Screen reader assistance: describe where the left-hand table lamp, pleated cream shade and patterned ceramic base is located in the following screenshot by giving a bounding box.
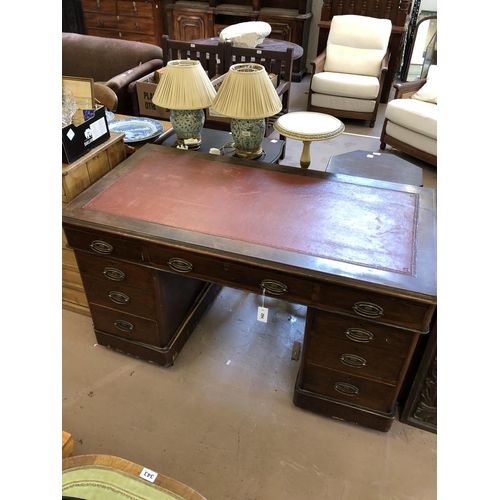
[153,59,215,148]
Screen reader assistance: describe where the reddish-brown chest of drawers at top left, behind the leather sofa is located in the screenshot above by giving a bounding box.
[81,0,163,47]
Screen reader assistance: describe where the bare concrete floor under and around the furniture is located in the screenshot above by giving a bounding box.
[62,78,437,500]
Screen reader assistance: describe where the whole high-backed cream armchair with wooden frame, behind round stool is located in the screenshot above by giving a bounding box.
[307,14,392,127]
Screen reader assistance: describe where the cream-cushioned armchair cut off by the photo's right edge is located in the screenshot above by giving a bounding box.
[380,65,437,166]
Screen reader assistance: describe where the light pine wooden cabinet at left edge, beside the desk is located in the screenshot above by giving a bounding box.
[62,132,126,316]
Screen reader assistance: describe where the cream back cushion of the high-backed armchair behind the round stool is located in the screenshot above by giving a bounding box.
[324,15,392,76]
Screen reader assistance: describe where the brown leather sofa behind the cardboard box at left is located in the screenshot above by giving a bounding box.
[62,33,163,115]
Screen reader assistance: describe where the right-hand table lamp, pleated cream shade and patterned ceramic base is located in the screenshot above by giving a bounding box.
[212,63,282,159]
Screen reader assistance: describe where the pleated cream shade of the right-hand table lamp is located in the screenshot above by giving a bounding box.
[210,63,282,120]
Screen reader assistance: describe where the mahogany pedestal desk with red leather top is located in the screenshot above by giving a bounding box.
[63,144,437,431]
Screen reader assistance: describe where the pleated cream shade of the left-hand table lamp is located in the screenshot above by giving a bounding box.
[153,59,215,110]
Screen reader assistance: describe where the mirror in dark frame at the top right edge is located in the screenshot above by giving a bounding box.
[401,16,437,82]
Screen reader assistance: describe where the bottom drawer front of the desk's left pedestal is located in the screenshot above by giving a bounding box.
[89,303,164,347]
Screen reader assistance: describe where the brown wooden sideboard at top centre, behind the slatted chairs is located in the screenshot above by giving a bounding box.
[164,0,312,81]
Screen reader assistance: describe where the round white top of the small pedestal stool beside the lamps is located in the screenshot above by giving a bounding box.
[274,111,345,141]
